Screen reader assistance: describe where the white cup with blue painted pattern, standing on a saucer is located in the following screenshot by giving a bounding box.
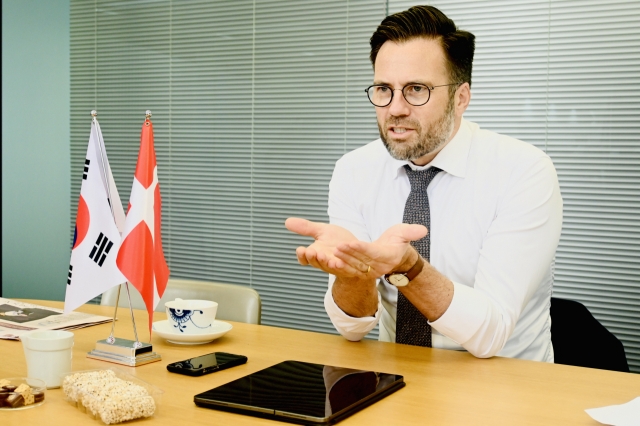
[164,298,218,334]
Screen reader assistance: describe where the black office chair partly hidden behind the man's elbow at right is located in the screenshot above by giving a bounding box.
[551,297,629,373]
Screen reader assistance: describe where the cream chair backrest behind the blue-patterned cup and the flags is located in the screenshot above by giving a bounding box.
[100,279,262,324]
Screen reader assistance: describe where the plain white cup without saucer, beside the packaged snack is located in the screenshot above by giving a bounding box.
[20,330,73,389]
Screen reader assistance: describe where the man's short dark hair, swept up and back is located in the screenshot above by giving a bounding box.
[369,6,476,85]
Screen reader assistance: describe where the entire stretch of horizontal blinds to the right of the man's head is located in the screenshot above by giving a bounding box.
[389,0,640,372]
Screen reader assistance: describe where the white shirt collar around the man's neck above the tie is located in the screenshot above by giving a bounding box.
[391,118,473,178]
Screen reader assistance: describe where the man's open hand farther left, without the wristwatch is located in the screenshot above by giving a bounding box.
[284,217,369,277]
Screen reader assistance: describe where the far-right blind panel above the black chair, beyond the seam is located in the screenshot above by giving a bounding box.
[548,0,640,372]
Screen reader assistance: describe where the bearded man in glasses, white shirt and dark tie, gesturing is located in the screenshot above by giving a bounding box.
[286,6,562,362]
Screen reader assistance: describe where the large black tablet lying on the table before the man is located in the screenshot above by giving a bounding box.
[194,361,405,425]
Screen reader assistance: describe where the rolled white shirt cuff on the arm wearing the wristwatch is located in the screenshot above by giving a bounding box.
[429,282,498,353]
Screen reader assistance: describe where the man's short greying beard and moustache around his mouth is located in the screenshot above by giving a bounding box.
[378,97,455,161]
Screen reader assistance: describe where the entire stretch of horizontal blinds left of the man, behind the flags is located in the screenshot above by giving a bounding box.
[71,0,385,338]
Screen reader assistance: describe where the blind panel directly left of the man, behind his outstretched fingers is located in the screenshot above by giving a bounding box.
[251,0,384,332]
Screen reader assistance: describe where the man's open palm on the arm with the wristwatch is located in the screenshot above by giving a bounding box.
[334,223,427,277]
